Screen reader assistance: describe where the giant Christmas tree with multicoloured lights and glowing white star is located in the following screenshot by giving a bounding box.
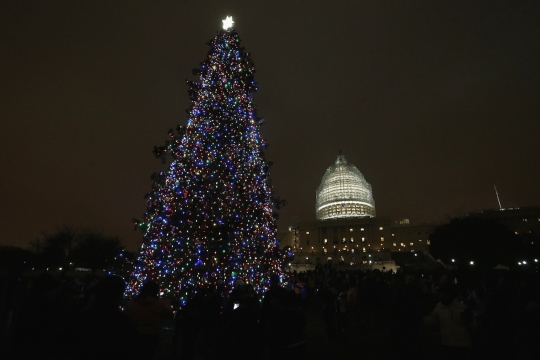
[128,18,282,306]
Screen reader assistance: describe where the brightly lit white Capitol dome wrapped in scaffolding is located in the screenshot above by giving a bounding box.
[316,152,375,220]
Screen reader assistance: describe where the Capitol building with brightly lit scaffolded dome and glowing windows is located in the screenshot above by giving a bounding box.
[279,152,434,269]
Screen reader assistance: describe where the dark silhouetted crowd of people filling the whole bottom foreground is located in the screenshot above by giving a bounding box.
[0,264,540,360]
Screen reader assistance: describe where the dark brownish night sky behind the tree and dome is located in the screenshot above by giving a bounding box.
[0,0,540,249]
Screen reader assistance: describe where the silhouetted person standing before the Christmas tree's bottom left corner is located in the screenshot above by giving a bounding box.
[126,281,172,359]
